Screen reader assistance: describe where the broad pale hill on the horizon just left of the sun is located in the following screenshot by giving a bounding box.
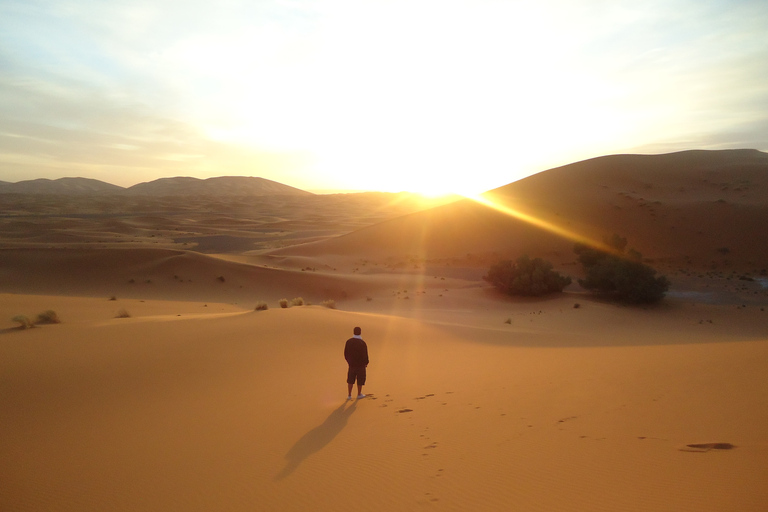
[125,176,314,196]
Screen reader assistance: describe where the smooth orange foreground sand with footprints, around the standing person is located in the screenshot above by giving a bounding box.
[0,294,768,511]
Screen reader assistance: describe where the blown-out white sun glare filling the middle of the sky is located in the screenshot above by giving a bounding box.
[192,2,656,198]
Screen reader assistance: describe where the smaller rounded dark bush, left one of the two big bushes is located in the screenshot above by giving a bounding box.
[483,256,571,296]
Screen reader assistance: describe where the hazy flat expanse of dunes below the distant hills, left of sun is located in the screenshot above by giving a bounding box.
[0,191,456,253]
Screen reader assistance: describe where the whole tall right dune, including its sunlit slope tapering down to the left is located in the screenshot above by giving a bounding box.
[274,150,768,267]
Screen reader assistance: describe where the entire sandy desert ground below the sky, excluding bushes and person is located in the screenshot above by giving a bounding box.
[0,150,768,512]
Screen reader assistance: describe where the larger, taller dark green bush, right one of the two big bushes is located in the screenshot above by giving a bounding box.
[574,235,670,304]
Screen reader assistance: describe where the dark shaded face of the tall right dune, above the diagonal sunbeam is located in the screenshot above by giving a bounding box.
[487,150,768,267]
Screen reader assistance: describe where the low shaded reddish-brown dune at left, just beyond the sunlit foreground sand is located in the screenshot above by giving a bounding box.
[0,249,387,302]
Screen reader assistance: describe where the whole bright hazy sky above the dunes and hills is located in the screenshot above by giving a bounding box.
[0,0,768,193]
